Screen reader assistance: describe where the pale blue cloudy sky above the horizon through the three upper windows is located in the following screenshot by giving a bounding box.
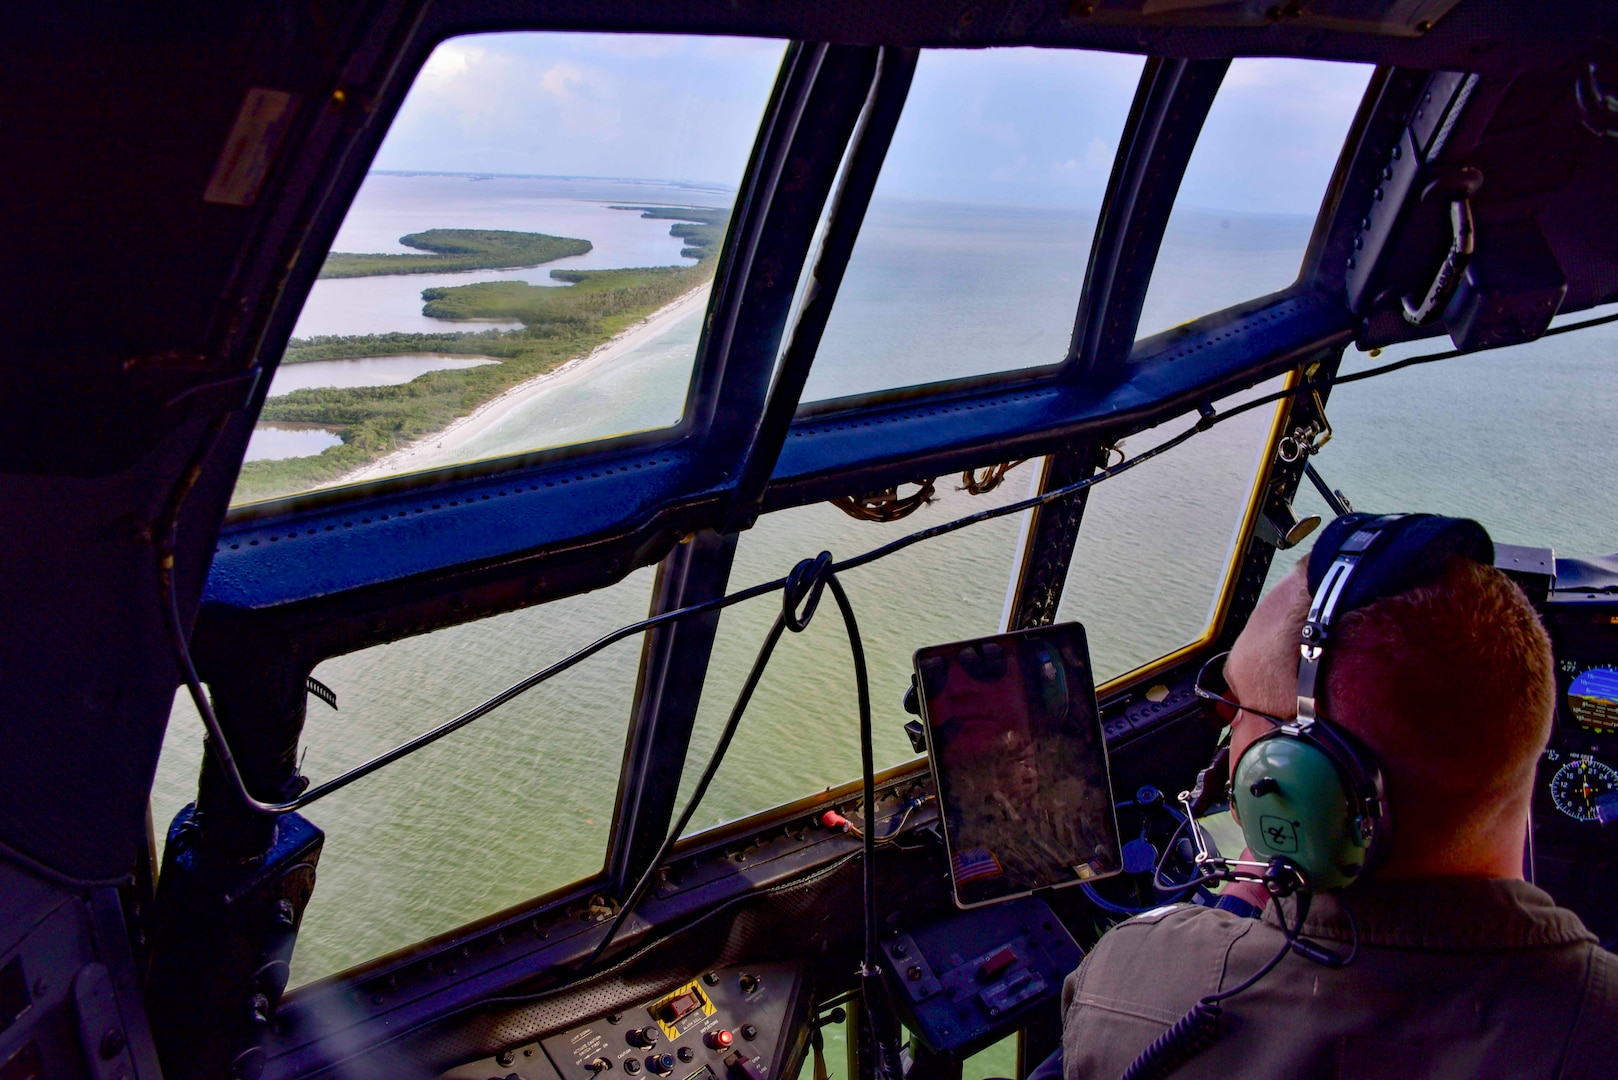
[375,32,1370,214]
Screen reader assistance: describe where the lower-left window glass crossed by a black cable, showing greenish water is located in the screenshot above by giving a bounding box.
[152,568,654,983]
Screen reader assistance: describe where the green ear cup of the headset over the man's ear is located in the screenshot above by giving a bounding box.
[1231,730,1369,889]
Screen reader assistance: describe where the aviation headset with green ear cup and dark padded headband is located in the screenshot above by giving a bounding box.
[1230,513,1495,891]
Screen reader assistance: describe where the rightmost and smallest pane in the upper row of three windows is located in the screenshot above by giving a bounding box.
[1139,58,1372,337]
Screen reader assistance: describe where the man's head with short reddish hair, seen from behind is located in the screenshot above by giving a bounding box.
[1225,555,1555,876]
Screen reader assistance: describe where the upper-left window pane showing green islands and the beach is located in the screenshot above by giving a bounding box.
[235,32,783,502]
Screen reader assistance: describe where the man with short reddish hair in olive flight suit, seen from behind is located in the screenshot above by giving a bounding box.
[1063,527,1618,1080]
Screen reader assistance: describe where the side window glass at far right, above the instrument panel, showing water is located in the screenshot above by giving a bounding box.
[1270,308,1618,583]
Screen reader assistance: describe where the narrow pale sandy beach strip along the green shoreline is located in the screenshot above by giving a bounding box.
[337,283,710,484]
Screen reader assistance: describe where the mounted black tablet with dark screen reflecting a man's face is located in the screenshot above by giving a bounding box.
[916,622,1120,908]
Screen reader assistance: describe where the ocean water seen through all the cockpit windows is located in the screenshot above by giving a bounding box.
[154,176,1618,983]
